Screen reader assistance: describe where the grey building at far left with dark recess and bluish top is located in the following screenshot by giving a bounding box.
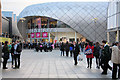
[2,11,21,41]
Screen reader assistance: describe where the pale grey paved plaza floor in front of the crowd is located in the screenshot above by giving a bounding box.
[2,50,111,78]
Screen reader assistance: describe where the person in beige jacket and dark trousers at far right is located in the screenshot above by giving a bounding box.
[111,42,120,79]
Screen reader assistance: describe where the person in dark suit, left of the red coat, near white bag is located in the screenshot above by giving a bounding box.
[73,42,80,65]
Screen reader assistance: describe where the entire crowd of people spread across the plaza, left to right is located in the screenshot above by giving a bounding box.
[2,40,120,79]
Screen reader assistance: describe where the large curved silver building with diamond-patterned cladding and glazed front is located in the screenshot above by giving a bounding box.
[18,2,108,42]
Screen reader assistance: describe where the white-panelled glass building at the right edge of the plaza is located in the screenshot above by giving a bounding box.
[107,0,120,43]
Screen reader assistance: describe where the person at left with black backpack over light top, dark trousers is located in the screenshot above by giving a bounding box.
[14,41,22,69]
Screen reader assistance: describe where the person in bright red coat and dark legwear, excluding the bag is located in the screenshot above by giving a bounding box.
[85,42,94,69]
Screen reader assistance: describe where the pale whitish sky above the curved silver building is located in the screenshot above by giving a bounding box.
[1,0,109,16]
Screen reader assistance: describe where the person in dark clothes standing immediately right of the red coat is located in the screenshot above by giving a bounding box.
[93,42,100,69]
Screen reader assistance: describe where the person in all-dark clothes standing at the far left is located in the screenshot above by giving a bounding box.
[2,41,9,69]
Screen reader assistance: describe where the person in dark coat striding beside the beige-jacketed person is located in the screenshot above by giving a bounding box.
[101,40,112,75]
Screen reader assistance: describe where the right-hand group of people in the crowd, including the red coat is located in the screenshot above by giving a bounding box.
[60,40,120,79]
